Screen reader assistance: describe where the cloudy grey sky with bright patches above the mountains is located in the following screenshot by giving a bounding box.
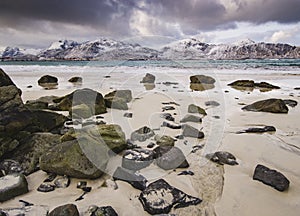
[0,0,300,48]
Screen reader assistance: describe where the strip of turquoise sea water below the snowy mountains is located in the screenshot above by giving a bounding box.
[0,59,300,69]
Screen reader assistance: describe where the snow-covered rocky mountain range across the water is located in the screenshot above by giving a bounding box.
[0,38,300,60]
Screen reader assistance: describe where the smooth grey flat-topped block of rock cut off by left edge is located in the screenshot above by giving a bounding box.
[0,173,28,202]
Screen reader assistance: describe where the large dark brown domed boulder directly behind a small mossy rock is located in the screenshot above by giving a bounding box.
[53,88,106,115]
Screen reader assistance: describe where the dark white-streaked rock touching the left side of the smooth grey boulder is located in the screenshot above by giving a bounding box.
[122,148,153,171]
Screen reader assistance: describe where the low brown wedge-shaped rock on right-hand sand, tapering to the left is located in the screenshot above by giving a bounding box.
[242,98,289,113]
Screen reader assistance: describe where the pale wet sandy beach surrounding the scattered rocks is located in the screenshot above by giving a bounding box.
[0,66,300,216]
